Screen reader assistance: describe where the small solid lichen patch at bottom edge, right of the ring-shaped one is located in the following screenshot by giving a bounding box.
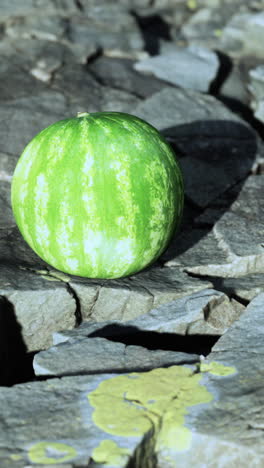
[92,440,130,466]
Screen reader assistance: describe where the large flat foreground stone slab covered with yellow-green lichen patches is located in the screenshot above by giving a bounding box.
[0,294,264,468]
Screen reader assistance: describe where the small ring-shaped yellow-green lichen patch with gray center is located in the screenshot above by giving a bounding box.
[28,441,77,465]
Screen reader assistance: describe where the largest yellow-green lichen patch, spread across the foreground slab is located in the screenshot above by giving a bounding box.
[88,366,213,450]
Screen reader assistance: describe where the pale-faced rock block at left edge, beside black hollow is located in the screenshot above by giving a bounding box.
[0,264,76,351]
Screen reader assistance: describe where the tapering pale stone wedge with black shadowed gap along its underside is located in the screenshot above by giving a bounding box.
[51,289,241,360]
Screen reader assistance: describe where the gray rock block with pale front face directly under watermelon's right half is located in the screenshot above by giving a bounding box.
[68,265,211,322]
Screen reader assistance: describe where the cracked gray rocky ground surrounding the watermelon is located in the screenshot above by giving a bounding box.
[0,0,264,468]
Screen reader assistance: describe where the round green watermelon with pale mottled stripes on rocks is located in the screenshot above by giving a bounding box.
[11,112,184,278]
